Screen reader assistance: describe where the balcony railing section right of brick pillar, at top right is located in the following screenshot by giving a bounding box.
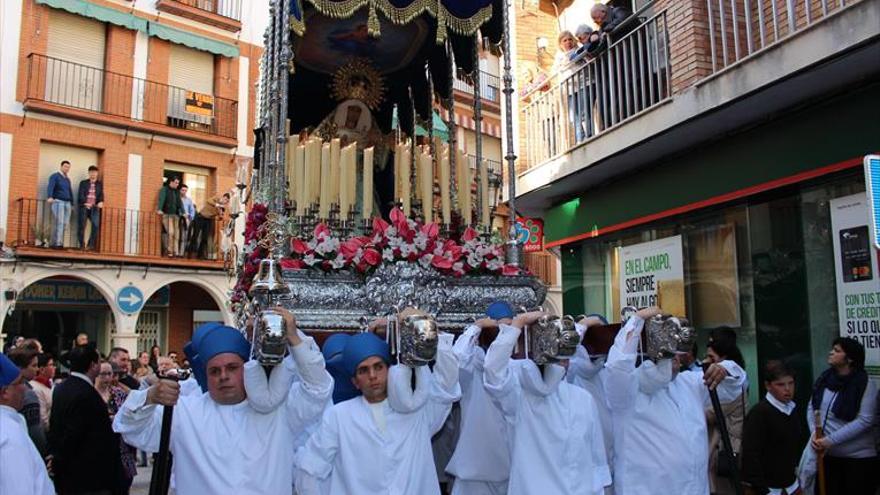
[706,0,862,73]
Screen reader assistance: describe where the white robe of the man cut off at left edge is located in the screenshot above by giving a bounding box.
[0,405,55,495]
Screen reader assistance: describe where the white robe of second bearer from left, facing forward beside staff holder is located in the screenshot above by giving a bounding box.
[295,338,461,495]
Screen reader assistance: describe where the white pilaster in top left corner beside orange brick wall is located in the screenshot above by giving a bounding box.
[0,0,23,116]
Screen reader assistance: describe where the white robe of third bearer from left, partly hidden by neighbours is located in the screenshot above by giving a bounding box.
[446,325,510,495]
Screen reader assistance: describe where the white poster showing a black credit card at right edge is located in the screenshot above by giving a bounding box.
[831,193,880,377]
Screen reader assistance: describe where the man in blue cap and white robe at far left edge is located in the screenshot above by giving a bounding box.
[0,354,55,495]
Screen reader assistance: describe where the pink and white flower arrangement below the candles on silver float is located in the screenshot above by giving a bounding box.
[282,208,522,277]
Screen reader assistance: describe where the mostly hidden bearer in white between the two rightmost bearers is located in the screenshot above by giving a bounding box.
[565,315,614,468]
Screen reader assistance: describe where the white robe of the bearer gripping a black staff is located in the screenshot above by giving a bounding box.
[113,342,333,495]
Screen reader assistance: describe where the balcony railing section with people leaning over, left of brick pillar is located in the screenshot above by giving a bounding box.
[522,10,672,167]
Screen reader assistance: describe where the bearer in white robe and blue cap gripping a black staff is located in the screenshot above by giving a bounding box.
[113,309,333,495]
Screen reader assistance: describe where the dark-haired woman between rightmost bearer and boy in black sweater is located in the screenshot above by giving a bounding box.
[706,328,748,495]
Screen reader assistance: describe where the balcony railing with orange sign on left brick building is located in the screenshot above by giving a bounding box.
[27,53,238,139]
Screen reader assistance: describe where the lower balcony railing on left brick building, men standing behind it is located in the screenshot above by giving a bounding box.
[8,198,231,269]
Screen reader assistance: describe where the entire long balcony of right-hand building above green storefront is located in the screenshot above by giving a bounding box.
[517,0,877,198]
